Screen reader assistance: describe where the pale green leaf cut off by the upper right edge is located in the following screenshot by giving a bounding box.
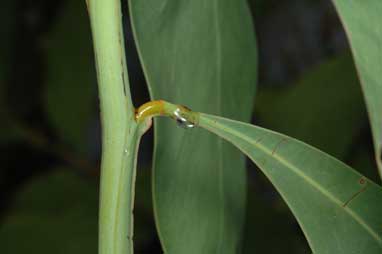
[333,0,382,177]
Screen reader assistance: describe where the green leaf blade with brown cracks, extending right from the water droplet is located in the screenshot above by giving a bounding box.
[199,114,382,254]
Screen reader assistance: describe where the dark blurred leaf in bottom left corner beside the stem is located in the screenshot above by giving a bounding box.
[0,169,98,254]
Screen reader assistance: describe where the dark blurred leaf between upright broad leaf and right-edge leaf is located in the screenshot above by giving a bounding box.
[255,54,366,158]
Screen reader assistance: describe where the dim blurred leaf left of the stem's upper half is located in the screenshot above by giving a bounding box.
[44,0,96,151]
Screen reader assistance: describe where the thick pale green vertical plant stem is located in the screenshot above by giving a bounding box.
[87,0,145,254]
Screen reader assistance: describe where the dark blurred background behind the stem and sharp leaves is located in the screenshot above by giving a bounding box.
[0,0,379,254]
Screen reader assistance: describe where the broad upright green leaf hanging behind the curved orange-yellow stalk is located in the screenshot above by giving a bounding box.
[130,0,257,254]
